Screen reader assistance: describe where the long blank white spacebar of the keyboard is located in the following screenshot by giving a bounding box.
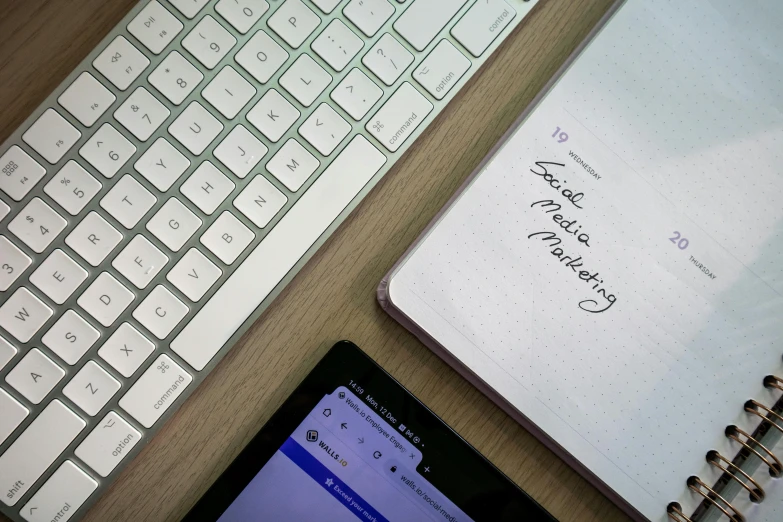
[171,136,386,371]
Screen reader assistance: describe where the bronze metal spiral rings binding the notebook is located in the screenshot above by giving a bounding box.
[666,375,783,522]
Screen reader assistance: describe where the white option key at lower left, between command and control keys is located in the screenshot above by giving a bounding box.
[74,411,141,477]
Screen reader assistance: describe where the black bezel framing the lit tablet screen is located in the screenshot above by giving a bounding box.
[184,341,556,522]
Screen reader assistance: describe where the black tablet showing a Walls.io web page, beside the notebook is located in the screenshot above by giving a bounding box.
[185,341,555,522]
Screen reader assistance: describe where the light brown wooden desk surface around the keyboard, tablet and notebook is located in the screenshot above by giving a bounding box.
[0,0,627,522]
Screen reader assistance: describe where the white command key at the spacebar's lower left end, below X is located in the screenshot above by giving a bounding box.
[119,355,193,424]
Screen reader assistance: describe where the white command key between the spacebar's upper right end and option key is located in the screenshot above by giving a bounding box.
[364,82,432,152]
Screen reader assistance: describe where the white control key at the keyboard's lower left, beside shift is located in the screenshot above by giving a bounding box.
[20,460,98,522]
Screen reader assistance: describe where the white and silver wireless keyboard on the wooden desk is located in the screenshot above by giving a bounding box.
[0,0,536,522]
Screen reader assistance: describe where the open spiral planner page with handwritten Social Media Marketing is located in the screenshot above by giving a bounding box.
[379,0,783,522]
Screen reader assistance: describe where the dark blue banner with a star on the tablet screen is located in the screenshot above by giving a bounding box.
[280,437,389,522]
